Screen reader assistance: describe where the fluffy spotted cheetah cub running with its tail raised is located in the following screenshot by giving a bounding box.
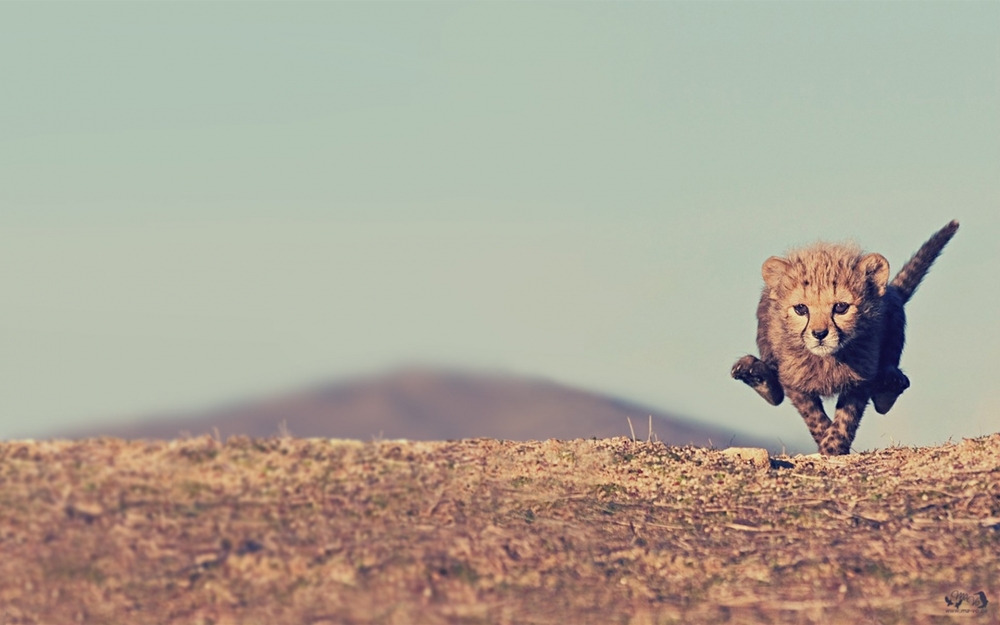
[731,221,958,456]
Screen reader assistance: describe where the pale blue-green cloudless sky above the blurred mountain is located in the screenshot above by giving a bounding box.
[0,2,1000,449]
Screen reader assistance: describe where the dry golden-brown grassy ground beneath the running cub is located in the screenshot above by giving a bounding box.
[0,435,1000,625]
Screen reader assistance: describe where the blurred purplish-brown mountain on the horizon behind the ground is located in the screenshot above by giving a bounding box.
[64,369,773,447]
